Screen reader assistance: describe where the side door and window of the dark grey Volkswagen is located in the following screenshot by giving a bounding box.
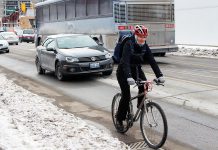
[46,39,57,71]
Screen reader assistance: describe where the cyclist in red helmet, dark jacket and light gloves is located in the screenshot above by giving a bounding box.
[116,25,165,130]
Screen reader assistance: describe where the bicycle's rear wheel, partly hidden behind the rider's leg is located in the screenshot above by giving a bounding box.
[111,93,129,133]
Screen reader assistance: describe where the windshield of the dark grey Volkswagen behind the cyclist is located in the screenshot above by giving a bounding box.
[57,35,98,49]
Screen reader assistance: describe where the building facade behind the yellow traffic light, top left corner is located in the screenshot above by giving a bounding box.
[0,0,42,31]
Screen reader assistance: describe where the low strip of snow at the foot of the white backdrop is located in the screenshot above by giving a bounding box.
[170,45,218,58]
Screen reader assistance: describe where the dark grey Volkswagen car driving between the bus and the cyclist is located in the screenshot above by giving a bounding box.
[35,34,113,80]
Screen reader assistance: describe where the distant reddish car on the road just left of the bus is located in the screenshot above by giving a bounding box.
[20,29,35,43]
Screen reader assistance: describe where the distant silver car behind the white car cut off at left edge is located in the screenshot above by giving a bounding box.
[0,32,19,45]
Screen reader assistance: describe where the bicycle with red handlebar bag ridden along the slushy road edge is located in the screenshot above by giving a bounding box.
[111,79,168,149]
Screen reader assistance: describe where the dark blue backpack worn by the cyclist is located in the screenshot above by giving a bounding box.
[112,31,133,63]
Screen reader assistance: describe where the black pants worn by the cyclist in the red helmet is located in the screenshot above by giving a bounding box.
[117,66,146,121]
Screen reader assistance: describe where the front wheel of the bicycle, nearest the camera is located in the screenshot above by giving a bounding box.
[140,102,168,149]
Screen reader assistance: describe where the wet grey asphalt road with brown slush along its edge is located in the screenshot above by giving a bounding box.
[0,43,218,149]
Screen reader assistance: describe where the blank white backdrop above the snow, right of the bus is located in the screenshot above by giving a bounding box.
[175,0,218,46]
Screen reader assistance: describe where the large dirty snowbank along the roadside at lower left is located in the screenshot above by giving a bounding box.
[0,74,130,150]
